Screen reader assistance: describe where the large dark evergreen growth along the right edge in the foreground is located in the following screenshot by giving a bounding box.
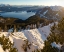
[42,18,64,52]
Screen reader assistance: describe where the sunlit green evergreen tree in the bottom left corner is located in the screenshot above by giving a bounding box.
[0,35,17,52]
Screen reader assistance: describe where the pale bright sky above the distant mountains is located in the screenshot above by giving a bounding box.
[0,0,64,6]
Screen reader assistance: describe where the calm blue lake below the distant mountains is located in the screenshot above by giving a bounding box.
[0,11,35,20]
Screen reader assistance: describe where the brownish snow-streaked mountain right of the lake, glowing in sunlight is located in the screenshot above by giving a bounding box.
[36,6,64,20]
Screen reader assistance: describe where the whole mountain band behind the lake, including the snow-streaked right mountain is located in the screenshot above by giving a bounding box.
[0,4,64,20]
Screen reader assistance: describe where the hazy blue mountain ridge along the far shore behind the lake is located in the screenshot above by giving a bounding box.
[0,4,44,12]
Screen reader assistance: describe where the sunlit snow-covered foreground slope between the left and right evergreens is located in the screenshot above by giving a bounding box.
[0,24,51,52]
